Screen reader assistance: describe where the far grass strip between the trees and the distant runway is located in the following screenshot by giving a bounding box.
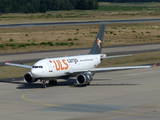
[0,3,160,24]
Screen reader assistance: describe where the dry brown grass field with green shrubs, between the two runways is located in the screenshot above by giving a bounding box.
[0,22,160,54]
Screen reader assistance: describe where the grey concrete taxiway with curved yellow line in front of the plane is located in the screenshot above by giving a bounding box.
[0,67,160,120]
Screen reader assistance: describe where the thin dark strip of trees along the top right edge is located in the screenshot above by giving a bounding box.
[97,0,160,3]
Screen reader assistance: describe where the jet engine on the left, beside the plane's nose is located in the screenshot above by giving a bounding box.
[23,72,38,83]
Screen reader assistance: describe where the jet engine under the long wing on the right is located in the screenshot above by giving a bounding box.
[76,73,93,85]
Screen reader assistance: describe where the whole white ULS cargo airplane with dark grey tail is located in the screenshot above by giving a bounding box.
[5,24,151,88]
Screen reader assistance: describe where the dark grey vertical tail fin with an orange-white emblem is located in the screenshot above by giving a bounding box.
[89,24,105,54]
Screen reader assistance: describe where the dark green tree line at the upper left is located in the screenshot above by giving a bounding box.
[0,0,98,13]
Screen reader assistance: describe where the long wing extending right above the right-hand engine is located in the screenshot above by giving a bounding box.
[69,66,152,74]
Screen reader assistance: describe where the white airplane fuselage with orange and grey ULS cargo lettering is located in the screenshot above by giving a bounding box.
[31,54,101,79]
